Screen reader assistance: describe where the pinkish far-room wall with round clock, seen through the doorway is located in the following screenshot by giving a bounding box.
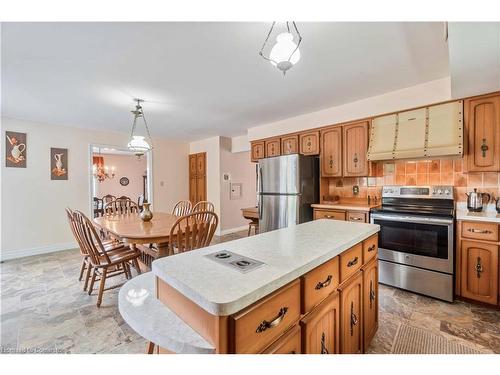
[94,154,147,202]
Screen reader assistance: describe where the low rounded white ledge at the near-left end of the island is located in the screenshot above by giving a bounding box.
[118,272,215,354]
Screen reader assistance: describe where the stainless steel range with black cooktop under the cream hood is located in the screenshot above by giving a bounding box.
[371,186,455,301]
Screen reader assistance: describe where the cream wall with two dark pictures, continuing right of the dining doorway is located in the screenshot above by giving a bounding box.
[1,118,189,259]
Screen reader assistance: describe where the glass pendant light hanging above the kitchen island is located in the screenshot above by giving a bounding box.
[259,21,302,75]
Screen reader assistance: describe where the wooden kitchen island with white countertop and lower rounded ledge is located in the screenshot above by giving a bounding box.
[119,220,379,353]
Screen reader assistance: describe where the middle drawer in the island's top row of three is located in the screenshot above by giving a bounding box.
[301,257,340,314]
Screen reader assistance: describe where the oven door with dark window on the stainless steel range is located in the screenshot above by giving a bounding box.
[371,213,453,274]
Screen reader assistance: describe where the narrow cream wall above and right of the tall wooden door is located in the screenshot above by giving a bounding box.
[189,137,221,235]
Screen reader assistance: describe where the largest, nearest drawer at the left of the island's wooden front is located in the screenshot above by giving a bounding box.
[229,280,300,353]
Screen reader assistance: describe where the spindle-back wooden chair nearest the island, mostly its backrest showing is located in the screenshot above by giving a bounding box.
[168,211,219,255]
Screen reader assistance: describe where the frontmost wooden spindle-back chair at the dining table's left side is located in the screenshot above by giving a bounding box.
[73,211,141,307]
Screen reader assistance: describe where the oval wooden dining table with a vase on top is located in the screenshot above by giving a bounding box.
[94,212,181,266]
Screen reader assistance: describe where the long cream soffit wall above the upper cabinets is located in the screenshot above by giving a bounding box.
[248,77,451,141]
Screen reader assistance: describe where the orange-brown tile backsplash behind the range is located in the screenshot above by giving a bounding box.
[328,159,500,202]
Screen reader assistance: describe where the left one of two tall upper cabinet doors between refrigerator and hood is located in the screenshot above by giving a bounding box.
[320,126,342,177]
